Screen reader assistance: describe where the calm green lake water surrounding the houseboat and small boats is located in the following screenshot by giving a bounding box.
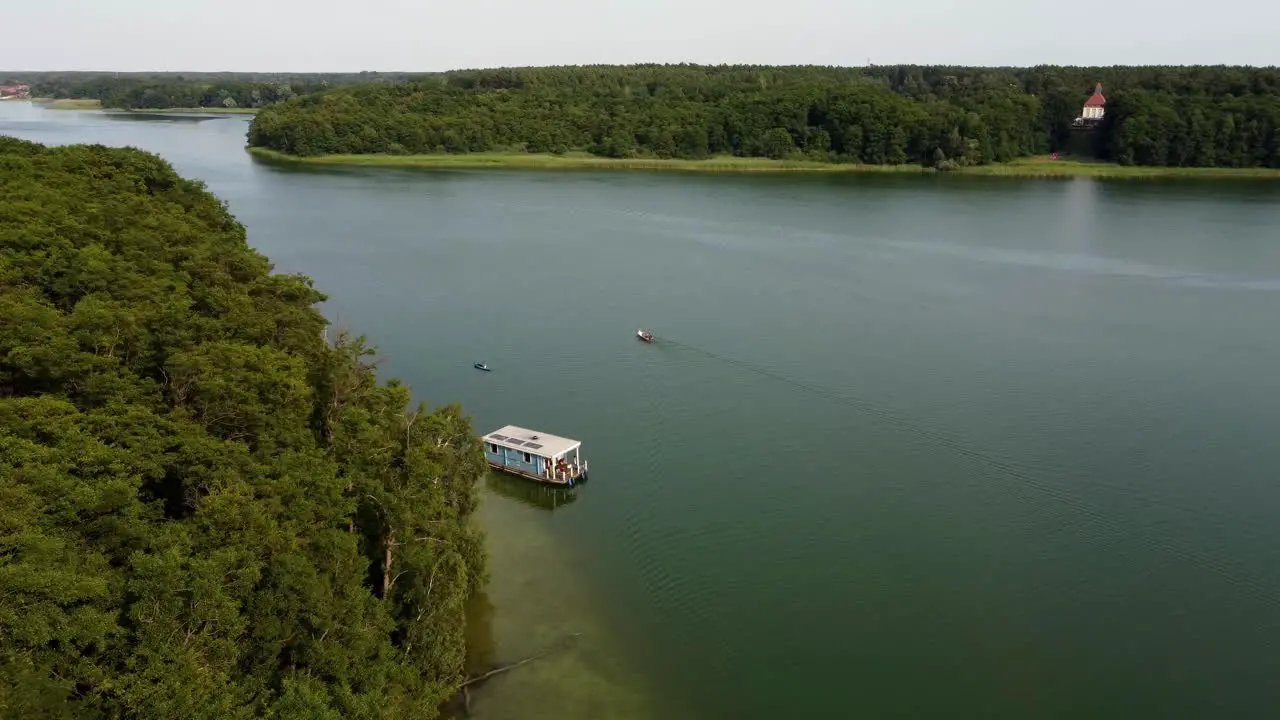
[0,102,1280,720]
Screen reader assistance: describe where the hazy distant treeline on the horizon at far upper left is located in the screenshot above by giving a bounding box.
[18,72,416,110]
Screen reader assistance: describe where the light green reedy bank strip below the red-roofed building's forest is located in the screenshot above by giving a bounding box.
[248,146,1280,179]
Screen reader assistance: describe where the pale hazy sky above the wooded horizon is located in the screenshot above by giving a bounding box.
[0,0,1280,72]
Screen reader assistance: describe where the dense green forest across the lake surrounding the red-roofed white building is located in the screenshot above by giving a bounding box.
[241,65,1280,169]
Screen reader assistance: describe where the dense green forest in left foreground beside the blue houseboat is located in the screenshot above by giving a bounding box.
[0,137,485,720]
